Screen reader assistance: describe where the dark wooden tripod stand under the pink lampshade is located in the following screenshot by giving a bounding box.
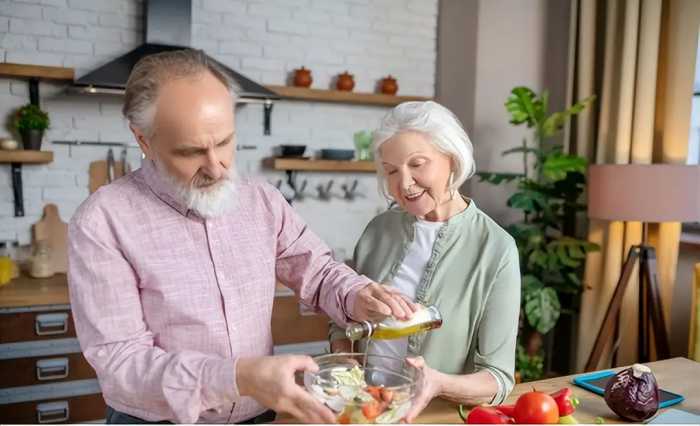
[586,241,670,371]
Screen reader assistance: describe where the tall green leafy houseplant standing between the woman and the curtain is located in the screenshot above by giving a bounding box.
[478,87,598,379]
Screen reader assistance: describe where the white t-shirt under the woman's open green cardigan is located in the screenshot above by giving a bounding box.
[369,219,444,358]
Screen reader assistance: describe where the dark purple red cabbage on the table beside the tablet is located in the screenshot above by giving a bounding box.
[605,364,659,423]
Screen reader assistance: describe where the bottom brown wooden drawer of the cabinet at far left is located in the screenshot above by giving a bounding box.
[0,394,107,424]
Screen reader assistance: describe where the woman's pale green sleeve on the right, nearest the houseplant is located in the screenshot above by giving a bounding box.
[474,240,520,404]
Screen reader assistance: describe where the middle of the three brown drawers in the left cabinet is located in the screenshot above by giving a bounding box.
[0,353,96,388]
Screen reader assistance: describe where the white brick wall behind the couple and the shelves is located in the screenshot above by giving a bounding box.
[0,0,437,256]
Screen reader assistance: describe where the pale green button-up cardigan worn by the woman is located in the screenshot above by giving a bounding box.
[330,200,520,404]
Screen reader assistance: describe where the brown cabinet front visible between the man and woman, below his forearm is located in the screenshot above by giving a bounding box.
[272,296,329,345]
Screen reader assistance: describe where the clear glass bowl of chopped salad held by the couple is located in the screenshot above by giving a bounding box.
[304,353,421,424]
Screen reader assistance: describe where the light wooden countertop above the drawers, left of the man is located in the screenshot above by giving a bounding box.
[0,274,70,308]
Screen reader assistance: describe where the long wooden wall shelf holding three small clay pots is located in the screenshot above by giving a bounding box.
[267,86,431,106]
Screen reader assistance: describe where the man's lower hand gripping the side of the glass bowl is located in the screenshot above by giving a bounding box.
[236,355,336,424]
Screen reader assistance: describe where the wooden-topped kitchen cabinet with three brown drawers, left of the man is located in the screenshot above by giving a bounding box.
[0,274,106,423]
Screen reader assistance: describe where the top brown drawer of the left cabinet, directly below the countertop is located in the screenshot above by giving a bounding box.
[0,310,75,343]
